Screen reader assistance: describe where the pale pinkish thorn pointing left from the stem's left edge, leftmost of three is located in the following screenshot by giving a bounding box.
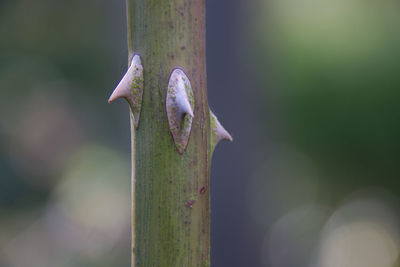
[108,55,143,128]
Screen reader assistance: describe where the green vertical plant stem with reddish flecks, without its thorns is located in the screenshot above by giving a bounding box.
[127,0,211,267]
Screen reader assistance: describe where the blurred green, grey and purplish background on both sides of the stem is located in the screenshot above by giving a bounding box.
[0,0,400,267]
